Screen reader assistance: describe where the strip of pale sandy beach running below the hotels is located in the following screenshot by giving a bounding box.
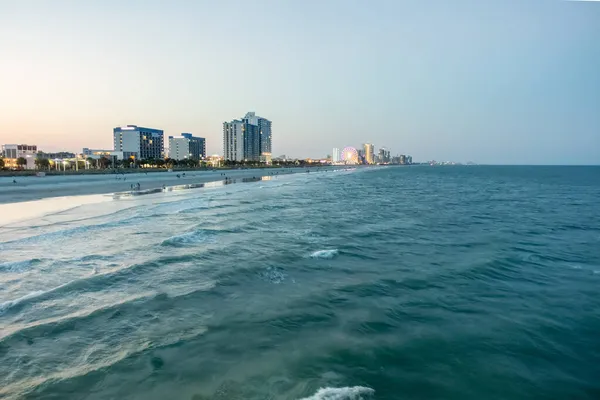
[0,168,325,204]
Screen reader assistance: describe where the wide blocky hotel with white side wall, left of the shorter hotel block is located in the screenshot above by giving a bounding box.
[113,125,165,160]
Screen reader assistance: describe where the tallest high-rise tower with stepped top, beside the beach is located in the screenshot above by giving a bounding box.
[223,112,272,163]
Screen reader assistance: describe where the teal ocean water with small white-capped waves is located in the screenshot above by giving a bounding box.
[0,166,600,400]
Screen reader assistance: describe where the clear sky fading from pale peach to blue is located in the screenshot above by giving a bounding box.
[0,0,600,164]
